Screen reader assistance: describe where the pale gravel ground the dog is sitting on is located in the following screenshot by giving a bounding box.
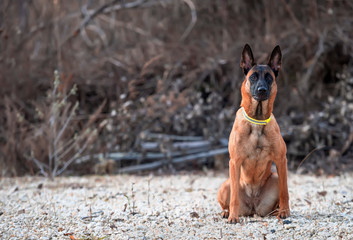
[0,172,353,239]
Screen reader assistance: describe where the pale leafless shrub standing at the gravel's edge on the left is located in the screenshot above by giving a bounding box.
[26,71,97,178]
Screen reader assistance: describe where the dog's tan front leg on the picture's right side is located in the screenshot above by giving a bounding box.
[275,156,290,218]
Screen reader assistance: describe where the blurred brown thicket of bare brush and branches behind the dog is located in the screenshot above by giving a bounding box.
[0,0,353,176]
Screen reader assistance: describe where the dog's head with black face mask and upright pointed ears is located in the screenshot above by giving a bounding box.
[240,44,282,102]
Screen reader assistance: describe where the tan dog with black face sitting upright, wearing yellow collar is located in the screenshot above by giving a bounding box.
[217,44,290,223]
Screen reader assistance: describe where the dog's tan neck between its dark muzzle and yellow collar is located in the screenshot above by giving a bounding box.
[240,84,276,120]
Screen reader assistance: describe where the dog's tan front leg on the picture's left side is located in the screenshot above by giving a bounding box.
[228,159,240,223]
